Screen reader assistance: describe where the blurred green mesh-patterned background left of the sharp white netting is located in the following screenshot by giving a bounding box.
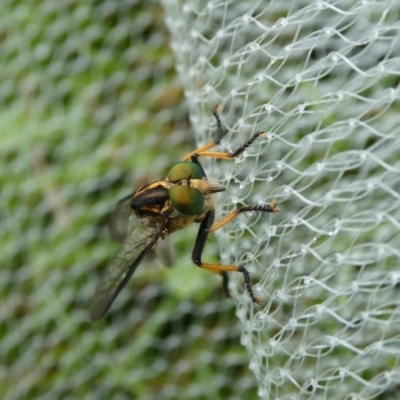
[0,0,256,400]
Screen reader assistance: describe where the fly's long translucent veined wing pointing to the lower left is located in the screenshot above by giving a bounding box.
[89,214,159,321]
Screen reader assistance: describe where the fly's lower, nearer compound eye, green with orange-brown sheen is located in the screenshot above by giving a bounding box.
[169,185,204,215]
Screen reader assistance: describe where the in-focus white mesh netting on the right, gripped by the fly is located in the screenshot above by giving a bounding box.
[164,0,400,399]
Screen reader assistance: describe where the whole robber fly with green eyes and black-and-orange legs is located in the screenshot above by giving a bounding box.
[90,109,279,320]
